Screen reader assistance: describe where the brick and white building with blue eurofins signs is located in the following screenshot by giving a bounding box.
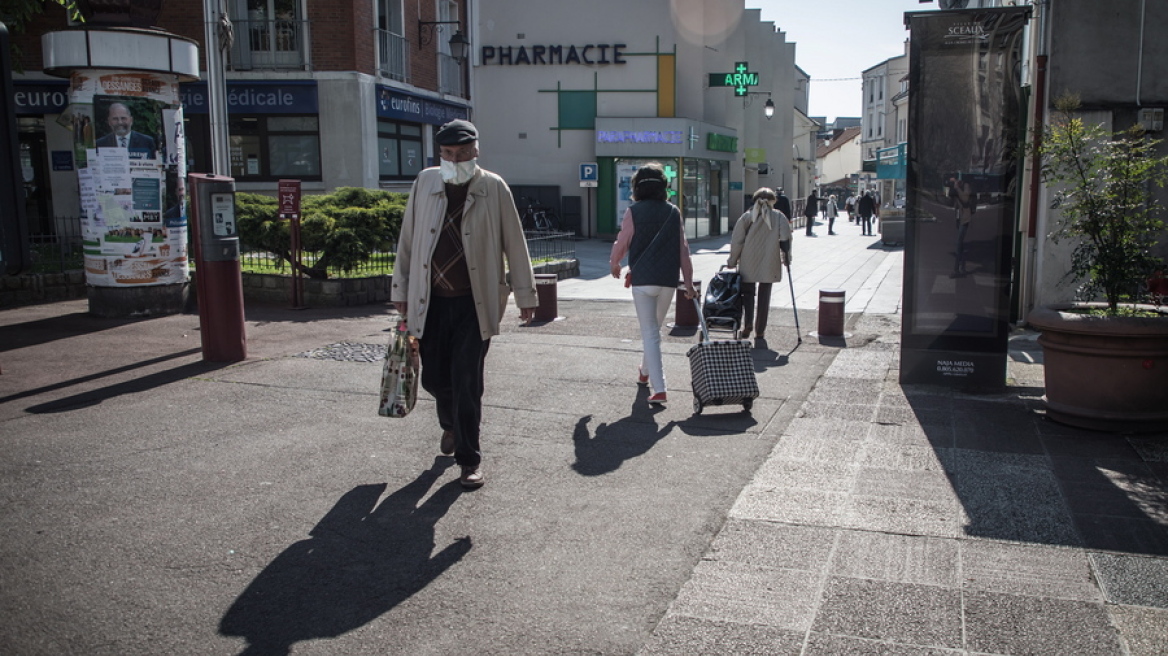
[14,0,471,233]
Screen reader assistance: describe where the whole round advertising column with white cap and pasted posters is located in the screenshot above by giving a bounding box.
[43,29,197,316]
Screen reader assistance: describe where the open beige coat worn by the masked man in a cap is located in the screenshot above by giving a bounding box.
[390,167,540,340]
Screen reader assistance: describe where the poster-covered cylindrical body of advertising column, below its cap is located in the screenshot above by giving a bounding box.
[70,70,188,287]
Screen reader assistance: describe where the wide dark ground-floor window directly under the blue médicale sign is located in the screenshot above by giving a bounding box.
[219,114,320,180]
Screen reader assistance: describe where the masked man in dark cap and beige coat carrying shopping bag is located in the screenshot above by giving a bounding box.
[390,120,540,488]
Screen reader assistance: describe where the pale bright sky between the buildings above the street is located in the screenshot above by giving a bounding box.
[746,0,937,120]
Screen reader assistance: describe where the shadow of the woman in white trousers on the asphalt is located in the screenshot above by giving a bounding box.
[572,388,677,476]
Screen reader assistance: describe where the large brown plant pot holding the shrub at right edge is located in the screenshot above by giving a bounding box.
[1028,303,1168,432]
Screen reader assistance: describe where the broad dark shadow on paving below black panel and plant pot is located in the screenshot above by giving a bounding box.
[903,386,1168,556]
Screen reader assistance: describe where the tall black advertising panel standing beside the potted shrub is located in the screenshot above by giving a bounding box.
[901,7,1029,388]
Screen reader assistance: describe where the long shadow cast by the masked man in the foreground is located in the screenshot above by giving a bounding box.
[220,458,471,656]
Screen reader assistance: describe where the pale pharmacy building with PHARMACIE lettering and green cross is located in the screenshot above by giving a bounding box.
[472,0,795,238]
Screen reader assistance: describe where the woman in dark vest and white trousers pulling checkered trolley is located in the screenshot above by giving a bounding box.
[609,162,697,405]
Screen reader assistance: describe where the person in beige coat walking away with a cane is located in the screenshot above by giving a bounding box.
[726,187,791,346]
